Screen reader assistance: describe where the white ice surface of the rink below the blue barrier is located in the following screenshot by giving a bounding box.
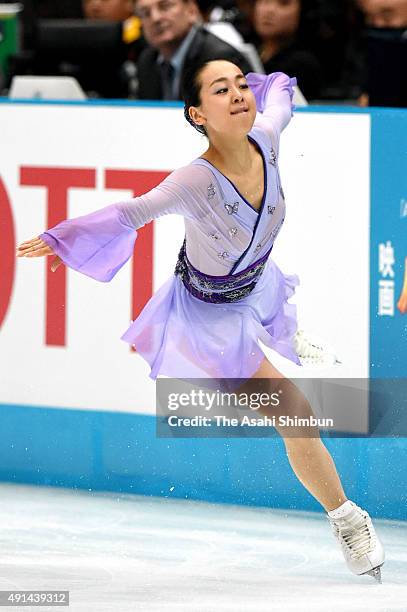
[0,483,407,612]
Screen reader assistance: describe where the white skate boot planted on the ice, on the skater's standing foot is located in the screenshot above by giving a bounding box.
[327,500,384,582]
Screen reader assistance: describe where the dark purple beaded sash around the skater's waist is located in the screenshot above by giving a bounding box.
[174,241,271,304]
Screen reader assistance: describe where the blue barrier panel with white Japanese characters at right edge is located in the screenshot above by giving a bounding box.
[369,110,407,378]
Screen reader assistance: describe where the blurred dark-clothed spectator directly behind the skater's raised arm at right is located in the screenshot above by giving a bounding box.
[253,0,322,99]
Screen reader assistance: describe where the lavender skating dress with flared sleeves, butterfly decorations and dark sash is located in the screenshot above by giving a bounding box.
[40,73,301,379]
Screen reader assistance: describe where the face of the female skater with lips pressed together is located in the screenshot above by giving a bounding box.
[189,60,256,140]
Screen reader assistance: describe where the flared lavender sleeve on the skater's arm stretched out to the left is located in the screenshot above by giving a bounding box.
[39,165,207,282]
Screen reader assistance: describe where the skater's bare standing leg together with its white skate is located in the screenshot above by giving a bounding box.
[237,359,384,582]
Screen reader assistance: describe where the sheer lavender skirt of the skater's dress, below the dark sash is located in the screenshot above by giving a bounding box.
[121,259,301,379]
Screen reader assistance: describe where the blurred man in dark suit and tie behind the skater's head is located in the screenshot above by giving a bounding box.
[136,0,251,100]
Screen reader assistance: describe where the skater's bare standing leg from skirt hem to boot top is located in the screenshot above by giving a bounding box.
[239,358,347,512]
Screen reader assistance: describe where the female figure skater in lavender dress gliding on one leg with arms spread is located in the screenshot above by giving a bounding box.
[17,60,384,581]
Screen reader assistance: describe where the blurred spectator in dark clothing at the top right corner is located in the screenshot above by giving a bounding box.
[358,0,407,107]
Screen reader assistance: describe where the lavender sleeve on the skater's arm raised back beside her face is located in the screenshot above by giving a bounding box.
[246,72,297,155]
